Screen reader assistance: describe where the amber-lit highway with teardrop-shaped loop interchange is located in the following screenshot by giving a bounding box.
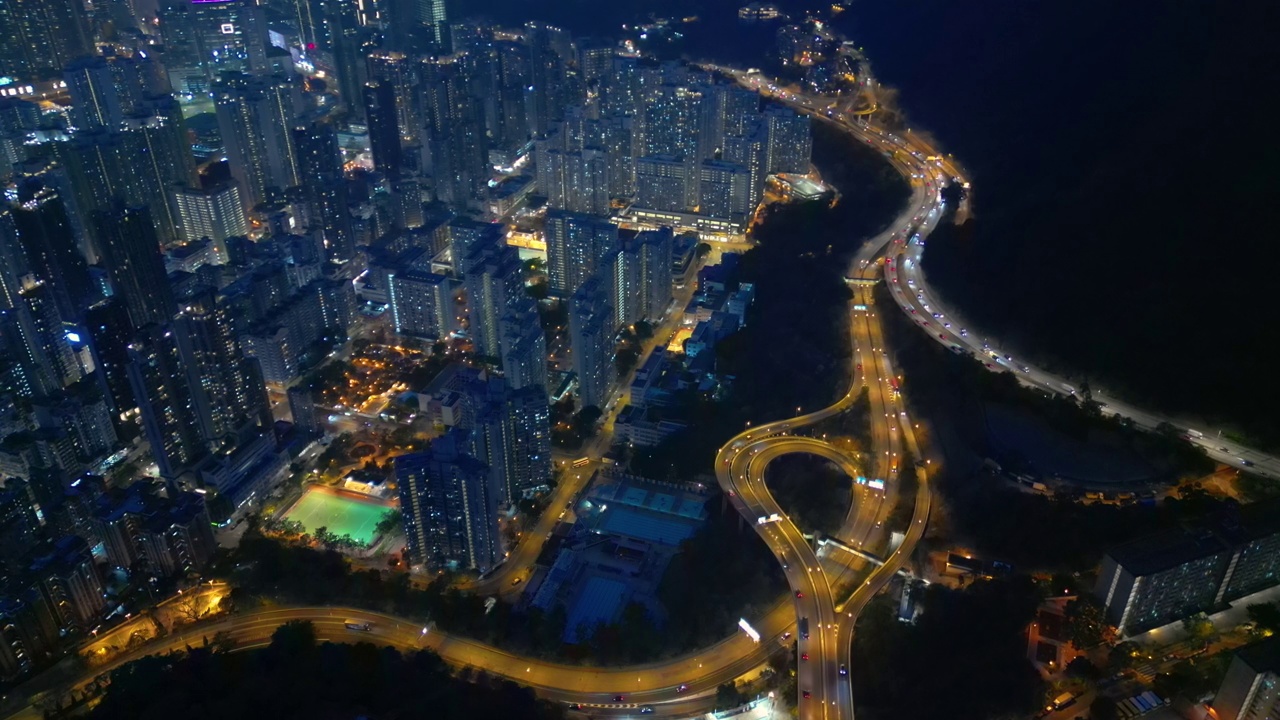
[7,61,952,720]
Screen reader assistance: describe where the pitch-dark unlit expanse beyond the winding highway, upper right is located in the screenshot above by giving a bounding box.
[468,0,1280,447]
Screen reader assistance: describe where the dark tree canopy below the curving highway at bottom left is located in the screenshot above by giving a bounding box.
[88,621,564,720]
